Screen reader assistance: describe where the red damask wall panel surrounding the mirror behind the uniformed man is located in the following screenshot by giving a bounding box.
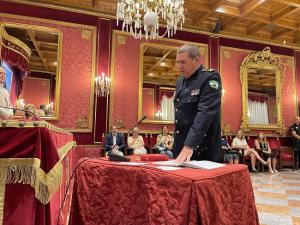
[110,33,208,132]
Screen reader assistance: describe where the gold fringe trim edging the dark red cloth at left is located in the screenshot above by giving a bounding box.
[0,141,76,205]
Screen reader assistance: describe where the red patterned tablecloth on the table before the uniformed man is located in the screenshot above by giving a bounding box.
[70,159,259,225]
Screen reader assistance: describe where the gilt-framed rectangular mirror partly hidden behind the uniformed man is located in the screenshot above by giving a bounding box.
[138,43,207,124]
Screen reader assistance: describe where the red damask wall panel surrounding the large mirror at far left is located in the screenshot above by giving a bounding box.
[0,16,96,131]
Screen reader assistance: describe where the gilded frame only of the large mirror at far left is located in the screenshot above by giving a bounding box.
[0,22,63,120]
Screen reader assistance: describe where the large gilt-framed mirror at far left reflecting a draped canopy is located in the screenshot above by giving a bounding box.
[1,23,62,119]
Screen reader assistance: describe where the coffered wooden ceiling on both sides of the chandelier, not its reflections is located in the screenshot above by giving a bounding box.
[9,0,300,48]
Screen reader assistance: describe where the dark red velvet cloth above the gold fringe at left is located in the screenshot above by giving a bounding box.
[0,127,73,173]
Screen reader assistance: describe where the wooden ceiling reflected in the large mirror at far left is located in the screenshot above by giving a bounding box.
[5,26,58,75]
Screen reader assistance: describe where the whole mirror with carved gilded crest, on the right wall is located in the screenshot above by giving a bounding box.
[241,48,284,133]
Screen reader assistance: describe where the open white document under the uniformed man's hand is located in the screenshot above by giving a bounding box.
[152,160,225,169]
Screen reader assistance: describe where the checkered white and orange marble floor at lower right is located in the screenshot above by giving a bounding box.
[251,170,300,225]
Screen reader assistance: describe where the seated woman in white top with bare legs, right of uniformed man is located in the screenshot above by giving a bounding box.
[231,130,268,172]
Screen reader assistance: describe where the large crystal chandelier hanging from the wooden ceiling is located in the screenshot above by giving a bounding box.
[116,0,185,40]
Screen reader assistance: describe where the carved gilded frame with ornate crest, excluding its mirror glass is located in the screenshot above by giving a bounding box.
[240,47,285,134]
